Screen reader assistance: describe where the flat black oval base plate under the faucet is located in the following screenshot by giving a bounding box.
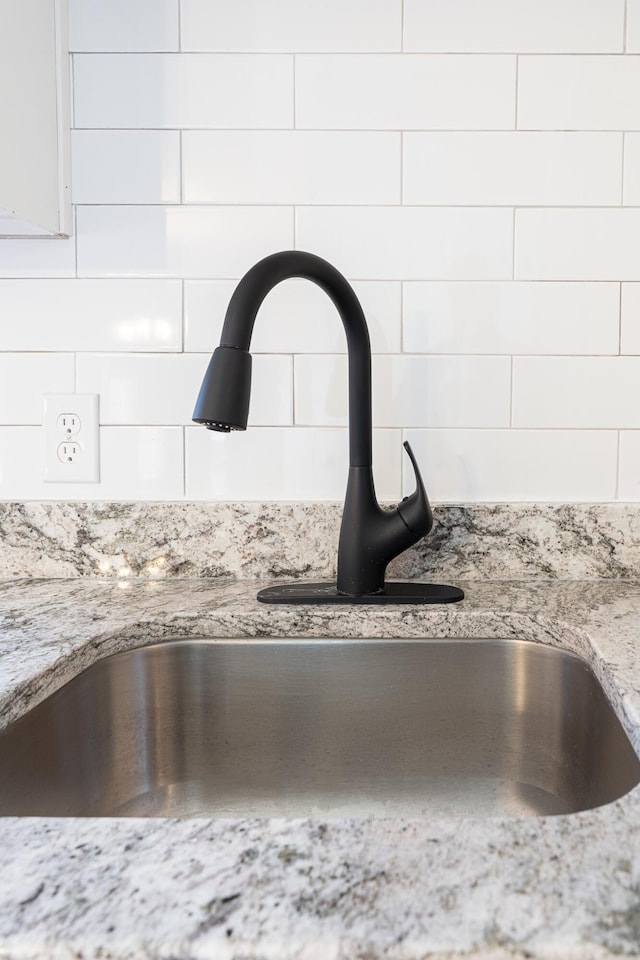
[258,580,464,604]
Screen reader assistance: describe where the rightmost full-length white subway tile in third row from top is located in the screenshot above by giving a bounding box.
[403,131,622,206]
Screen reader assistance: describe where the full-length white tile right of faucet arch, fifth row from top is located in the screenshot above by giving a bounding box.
[403,281,620,355]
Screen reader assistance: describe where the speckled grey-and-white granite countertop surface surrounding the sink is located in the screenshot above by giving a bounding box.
[0,579,640,960]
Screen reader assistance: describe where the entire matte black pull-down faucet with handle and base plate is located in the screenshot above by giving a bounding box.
[193,250,464,603]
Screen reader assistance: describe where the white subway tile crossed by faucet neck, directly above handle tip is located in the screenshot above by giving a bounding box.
[294,356,511,427]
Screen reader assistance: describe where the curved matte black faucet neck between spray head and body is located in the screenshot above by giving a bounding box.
[220,250,372,467]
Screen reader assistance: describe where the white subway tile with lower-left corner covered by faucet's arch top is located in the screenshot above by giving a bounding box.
[296,207,513,280]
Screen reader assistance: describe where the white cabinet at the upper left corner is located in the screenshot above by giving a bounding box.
[0,0,71,236]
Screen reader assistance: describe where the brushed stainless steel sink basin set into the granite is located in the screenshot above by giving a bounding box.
[0,640,640,817]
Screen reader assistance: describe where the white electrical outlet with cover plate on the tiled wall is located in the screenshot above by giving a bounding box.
[42,393,100,483]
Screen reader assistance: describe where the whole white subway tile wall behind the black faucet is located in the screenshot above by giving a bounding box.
[0,0,640,501]
